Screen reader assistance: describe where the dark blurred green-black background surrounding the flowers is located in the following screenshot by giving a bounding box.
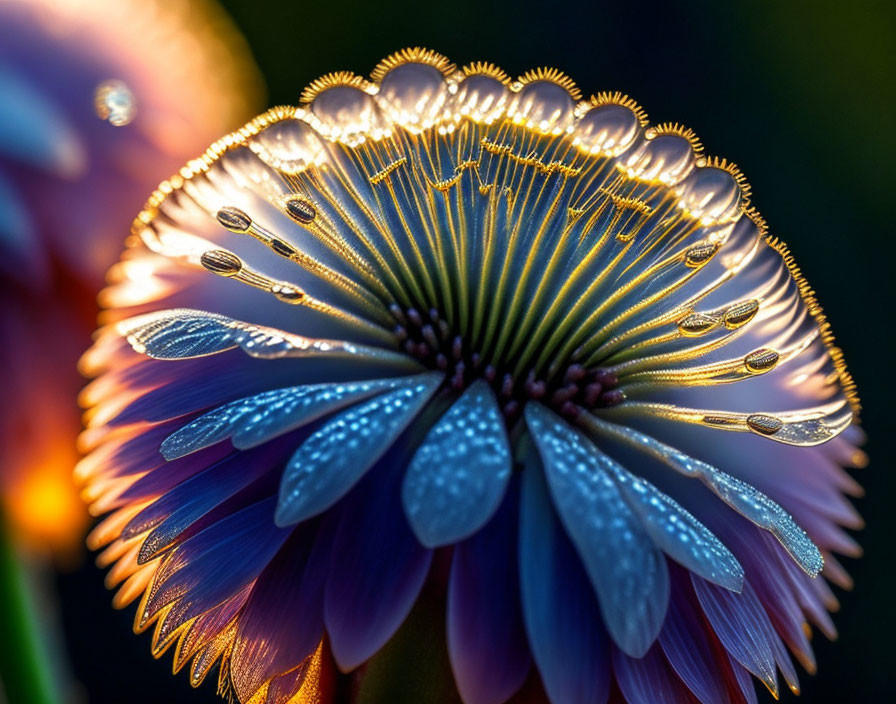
[59,0,896,704]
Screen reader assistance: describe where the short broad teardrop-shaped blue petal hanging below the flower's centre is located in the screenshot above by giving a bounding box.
[402,380,512,548]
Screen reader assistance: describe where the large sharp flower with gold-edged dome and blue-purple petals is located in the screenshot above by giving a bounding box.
[78,49,864,704]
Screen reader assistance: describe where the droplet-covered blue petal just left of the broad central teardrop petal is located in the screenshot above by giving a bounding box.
[274,373,442,526]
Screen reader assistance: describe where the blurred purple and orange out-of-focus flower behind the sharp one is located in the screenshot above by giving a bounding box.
[0,0,259,552]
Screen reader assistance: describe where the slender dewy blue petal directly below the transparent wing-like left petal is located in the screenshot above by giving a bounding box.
[161,378,409,460]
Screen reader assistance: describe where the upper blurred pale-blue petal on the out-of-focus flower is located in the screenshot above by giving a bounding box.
[0,67,87,179]
